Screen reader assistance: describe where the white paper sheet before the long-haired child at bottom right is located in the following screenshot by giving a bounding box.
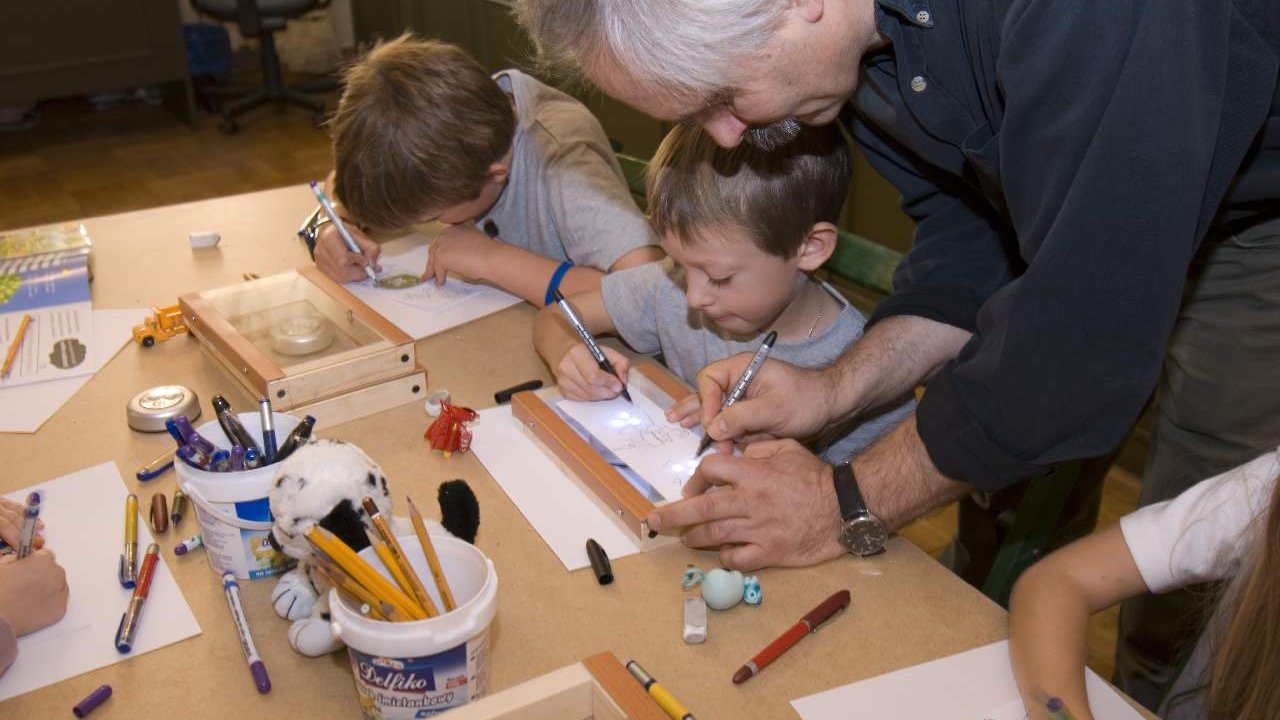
[791,641,1142,720]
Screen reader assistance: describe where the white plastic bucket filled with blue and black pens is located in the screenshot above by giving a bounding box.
[173,413,301,580]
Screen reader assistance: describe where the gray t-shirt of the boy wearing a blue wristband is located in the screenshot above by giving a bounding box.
[476,70,657,270]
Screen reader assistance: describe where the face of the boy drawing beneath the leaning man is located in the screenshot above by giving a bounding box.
[662,227,801,334]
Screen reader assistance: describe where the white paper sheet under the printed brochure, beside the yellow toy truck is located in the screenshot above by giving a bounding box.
[0,309,147,433]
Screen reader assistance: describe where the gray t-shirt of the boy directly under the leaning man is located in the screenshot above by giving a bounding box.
[600,258,915,464]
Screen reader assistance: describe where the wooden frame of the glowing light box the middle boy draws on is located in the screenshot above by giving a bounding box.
[511,363,692,550]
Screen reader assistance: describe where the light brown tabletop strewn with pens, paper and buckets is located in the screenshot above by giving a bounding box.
[0,186,1006,720]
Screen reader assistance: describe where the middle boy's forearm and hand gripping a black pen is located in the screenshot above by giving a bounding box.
[534,290,631,400]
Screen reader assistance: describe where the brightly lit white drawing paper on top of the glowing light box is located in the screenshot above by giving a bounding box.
[557,391,699,502]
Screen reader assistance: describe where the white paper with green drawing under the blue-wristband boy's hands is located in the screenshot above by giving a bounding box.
[344,236,521,340]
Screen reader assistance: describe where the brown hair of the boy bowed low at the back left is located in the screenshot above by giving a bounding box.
[330,35,516,228]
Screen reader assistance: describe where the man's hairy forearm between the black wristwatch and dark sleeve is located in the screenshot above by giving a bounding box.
[854,415,973,530]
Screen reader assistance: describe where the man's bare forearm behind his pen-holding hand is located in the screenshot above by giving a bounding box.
[828,315,973,420]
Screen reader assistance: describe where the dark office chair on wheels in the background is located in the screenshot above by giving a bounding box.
[191,0,338,135]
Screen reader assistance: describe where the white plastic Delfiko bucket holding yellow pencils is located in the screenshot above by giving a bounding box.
[329,533,498,720]
